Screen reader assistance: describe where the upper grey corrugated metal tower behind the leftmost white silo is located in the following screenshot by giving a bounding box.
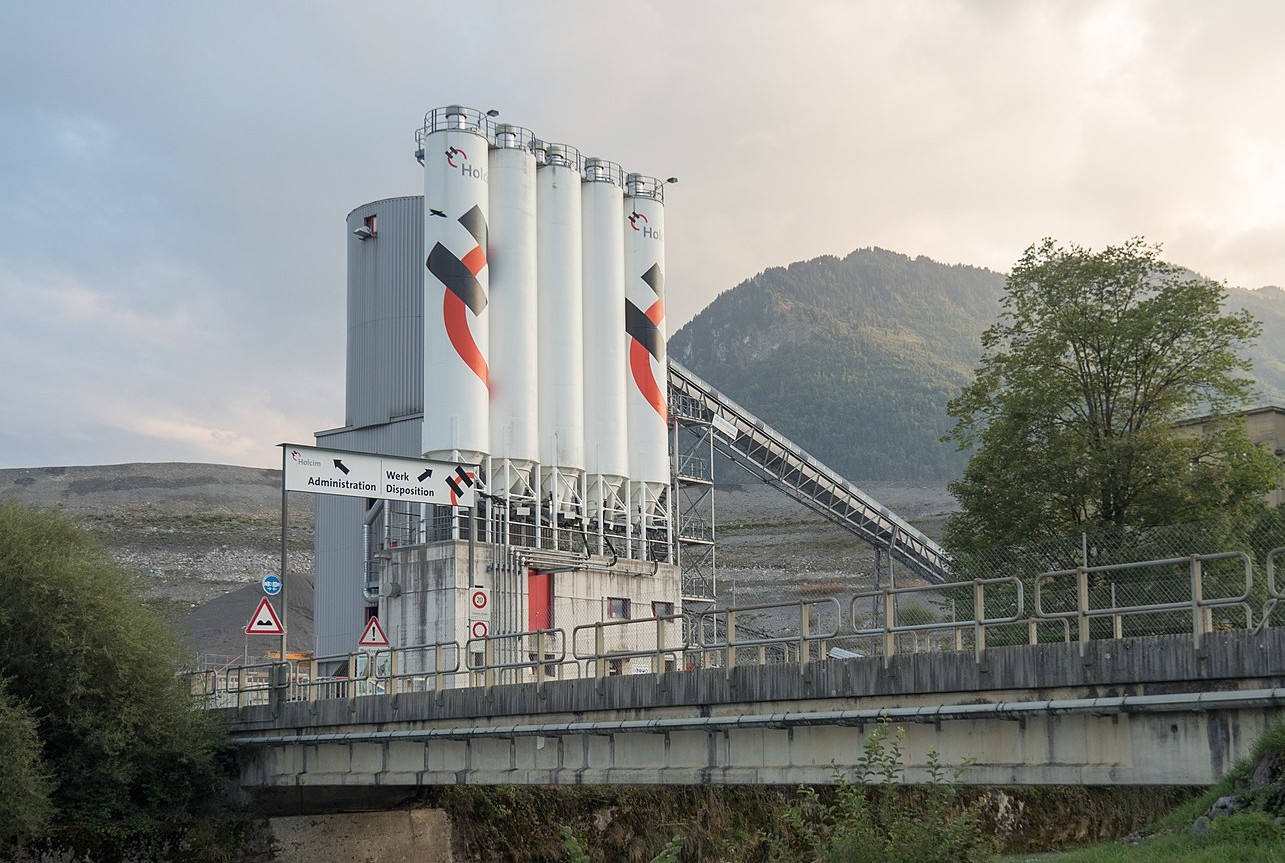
[346,195,424,423]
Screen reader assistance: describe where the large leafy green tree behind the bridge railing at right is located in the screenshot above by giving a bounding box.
[943,239,1280,554]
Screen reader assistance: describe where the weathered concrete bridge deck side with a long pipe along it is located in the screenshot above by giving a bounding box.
[221,629,1285,798]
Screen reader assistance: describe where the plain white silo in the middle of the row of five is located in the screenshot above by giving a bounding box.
[536,144,585,524]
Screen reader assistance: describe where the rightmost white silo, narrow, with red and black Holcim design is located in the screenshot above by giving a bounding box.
[623,173,669,524]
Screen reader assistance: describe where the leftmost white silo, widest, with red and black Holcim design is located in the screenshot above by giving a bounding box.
[420,105,491,464]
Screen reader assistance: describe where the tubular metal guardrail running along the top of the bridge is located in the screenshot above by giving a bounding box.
[185,546,1285,708]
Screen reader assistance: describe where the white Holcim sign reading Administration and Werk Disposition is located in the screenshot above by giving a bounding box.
[281,443,477,506]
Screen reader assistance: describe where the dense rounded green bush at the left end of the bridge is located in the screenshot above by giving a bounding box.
[0,502,224,859]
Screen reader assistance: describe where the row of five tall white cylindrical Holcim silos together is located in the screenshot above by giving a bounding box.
[418,105,669,550]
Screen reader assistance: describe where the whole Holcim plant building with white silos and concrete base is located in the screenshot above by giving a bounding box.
[314,105,682,686]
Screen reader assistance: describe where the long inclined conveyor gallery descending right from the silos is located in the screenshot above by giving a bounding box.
[669,358,950,584]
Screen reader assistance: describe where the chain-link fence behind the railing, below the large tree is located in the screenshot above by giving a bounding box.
[812,510,1285,656]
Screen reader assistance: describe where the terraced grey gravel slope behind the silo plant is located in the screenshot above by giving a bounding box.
[0,464,955,658]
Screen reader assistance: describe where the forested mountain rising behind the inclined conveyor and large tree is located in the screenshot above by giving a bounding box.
[668,248,1285,482]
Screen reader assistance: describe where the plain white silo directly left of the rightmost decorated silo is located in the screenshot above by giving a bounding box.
[581,159,630,541]
